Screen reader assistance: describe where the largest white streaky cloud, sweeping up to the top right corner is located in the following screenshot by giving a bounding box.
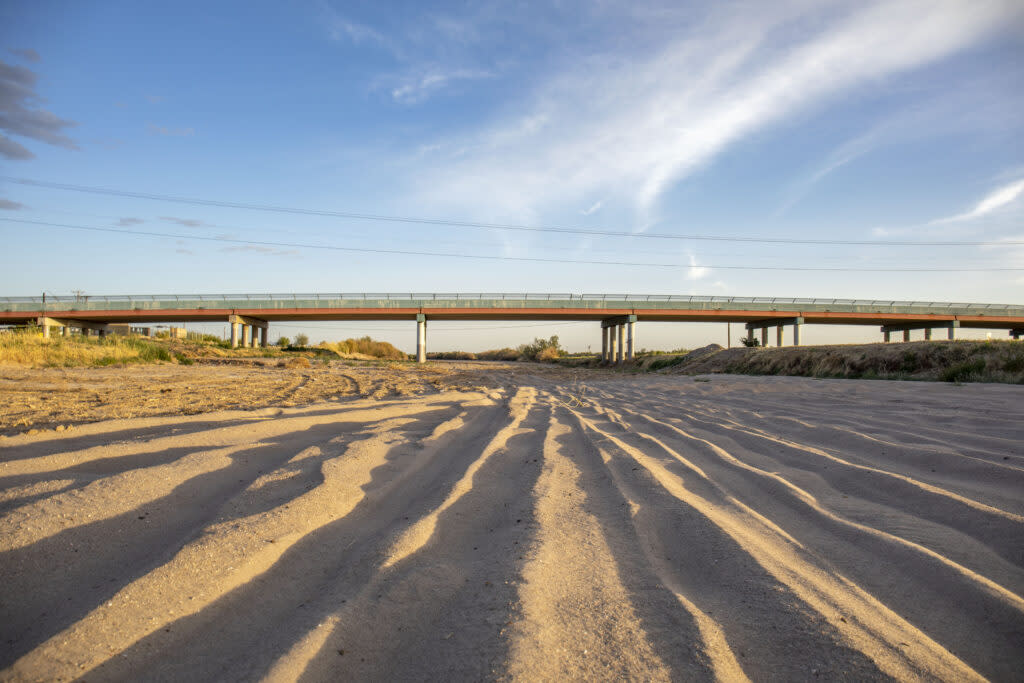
[417,0,1020,222]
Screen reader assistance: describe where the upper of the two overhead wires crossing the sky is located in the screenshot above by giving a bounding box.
[0,175,1024,247]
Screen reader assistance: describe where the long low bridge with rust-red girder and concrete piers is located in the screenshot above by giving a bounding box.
[0,293,1024,362]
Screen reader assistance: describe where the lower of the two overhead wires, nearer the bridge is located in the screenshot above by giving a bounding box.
[0,218,1024,272]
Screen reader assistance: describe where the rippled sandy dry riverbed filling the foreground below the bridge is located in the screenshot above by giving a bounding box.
[0,364,1024,681]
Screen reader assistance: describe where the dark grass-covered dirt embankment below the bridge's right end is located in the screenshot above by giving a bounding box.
[637,341,1024,384]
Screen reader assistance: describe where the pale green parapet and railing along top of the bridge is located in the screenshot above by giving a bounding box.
[0,293,1024,316]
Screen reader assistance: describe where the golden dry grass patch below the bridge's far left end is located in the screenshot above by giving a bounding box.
[0,331,174,368]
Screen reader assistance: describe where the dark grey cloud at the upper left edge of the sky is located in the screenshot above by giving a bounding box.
[0,61,78,161]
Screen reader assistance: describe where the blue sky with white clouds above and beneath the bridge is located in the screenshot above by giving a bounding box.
[0,0,1024,350]
